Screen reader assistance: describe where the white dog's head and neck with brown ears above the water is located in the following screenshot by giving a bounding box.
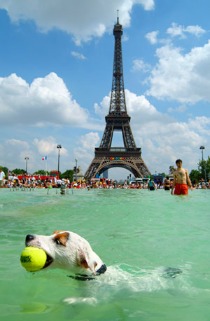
[25,231,107,280]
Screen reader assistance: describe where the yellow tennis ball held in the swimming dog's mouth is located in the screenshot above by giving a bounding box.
[20,246,47,272]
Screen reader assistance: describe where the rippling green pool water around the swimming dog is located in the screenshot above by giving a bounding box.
[0,189,210,321]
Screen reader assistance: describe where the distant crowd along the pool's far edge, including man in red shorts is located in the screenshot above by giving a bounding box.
[0,159,210,195]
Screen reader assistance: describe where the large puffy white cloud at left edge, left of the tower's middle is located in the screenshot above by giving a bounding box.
[0,73,89,127]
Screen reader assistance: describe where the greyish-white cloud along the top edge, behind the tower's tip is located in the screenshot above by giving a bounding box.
[0,0,154,44]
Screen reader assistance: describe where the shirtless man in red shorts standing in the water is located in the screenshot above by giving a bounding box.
[171,159,192,195]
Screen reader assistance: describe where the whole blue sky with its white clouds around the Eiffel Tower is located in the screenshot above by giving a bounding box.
[0,0,210,178]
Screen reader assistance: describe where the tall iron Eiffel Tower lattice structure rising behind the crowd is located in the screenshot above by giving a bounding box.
[84,17,150,180]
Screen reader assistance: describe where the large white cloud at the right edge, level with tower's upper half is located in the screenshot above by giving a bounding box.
[147,41,210,103]
